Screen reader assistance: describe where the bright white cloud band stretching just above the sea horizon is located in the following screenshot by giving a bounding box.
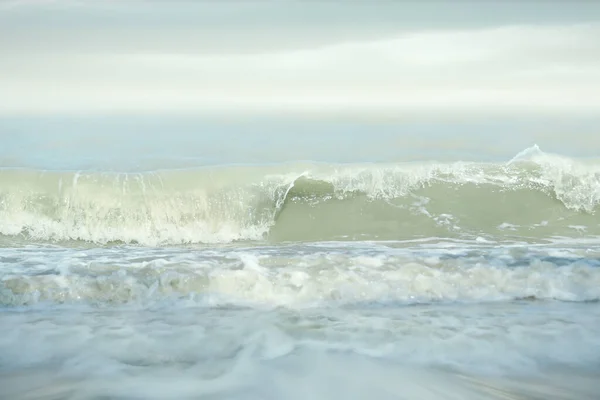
[0,4,600,115]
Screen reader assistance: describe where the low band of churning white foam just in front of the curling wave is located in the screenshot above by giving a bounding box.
[0,240,600,308]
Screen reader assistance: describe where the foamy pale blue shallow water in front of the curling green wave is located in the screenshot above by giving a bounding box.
[0,240,600,399]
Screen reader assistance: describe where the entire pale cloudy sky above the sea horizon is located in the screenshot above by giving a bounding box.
[0,0,600,118]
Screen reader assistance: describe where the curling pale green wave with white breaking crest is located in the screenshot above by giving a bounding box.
[0,146,600,245]
